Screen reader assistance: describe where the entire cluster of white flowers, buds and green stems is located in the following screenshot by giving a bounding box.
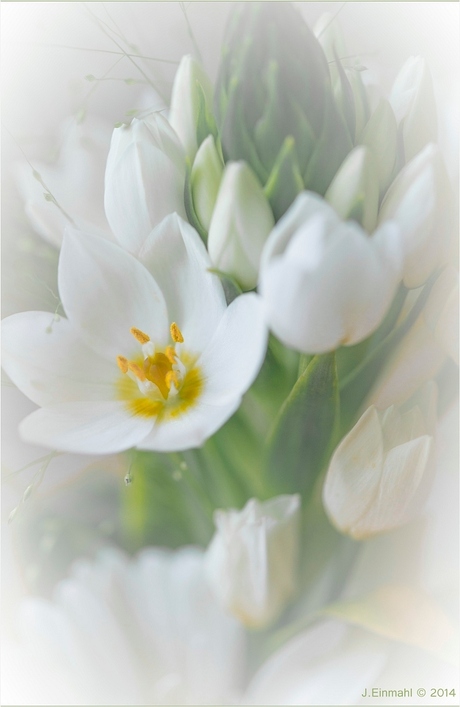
[2,3,458,704]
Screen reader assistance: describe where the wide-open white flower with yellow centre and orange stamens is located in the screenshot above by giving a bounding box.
[3,215,266,454]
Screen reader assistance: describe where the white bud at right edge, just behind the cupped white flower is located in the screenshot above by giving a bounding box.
[379,144,452,288]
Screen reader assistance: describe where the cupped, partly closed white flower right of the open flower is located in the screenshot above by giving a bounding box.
[260,192,401,353]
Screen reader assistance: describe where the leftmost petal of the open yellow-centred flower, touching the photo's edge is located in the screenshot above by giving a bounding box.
[2,312,118,405]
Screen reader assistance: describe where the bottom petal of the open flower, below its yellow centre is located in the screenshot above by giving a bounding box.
[136,397,241,452]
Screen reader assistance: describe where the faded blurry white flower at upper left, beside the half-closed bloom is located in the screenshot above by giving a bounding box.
[16,116,112,247]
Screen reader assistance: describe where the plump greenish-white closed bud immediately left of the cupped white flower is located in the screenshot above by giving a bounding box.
[208,162,275,290]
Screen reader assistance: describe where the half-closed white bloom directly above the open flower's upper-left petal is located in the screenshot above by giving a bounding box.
[105,142,185,253]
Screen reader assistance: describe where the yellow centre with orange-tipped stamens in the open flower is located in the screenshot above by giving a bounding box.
[117,322,203,419]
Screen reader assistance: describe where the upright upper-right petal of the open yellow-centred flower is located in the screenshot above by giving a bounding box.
[139,214,227,353]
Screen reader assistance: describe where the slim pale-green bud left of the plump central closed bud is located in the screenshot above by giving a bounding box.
[190,135,224,231]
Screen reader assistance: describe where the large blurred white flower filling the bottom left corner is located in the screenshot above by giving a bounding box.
[3,547,245,705]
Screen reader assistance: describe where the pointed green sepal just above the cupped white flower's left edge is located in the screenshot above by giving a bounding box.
[264,136,304,221]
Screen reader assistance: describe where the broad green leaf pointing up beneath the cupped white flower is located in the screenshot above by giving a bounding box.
[267,353,339,497]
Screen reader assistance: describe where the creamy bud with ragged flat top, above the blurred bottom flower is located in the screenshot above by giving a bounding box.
[206,495,300,627]
